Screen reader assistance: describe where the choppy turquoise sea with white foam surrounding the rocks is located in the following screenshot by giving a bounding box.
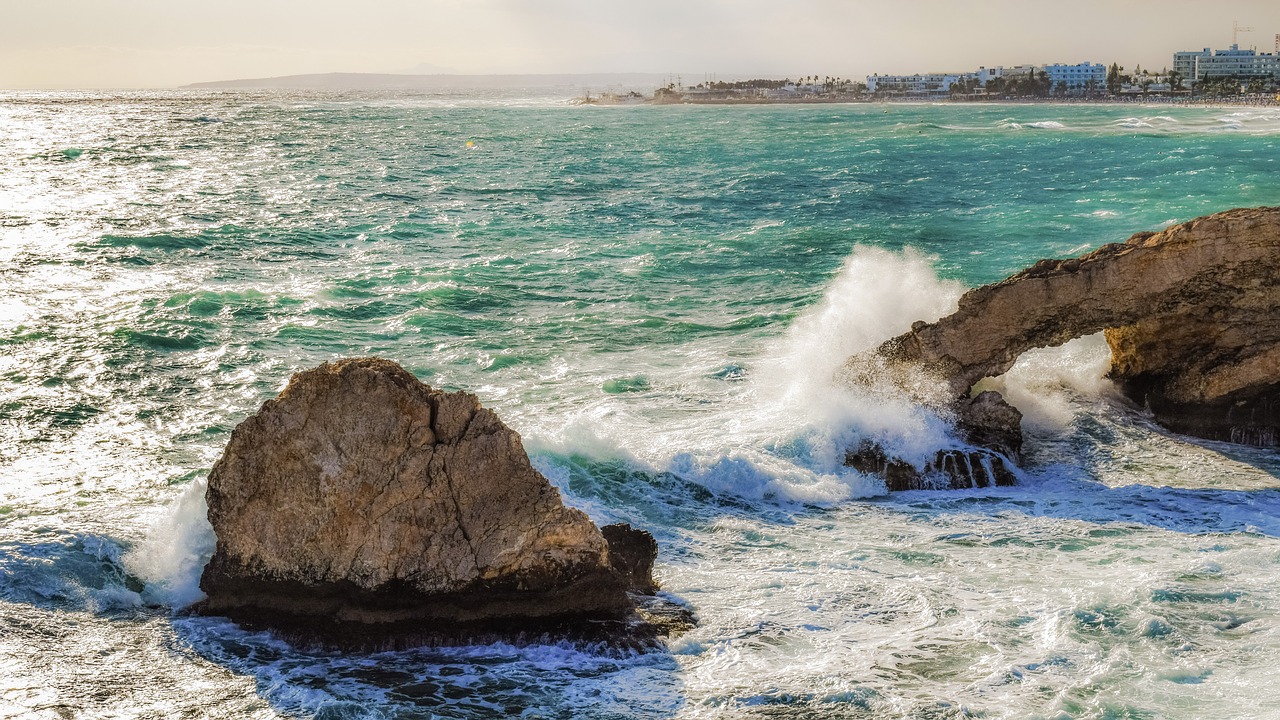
[0,88,1280,720]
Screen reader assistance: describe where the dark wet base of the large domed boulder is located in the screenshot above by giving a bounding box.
[189,524,696,651]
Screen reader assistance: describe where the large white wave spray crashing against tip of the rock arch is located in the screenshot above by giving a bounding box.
[526,247,964,505]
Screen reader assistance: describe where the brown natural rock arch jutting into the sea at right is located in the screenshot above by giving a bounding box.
[849,208,1280,486]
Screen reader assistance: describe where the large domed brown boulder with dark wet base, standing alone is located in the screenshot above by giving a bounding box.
[198,357,686,635]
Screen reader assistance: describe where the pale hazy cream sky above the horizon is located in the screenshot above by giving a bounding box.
[0,0,1280,88]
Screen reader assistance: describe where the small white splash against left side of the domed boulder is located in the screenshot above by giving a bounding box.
[124,479,216,607]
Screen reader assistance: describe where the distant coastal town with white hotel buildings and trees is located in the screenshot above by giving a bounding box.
[577,35,1280,105]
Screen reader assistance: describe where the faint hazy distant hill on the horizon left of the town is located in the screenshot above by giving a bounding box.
[183,73,671,90]
